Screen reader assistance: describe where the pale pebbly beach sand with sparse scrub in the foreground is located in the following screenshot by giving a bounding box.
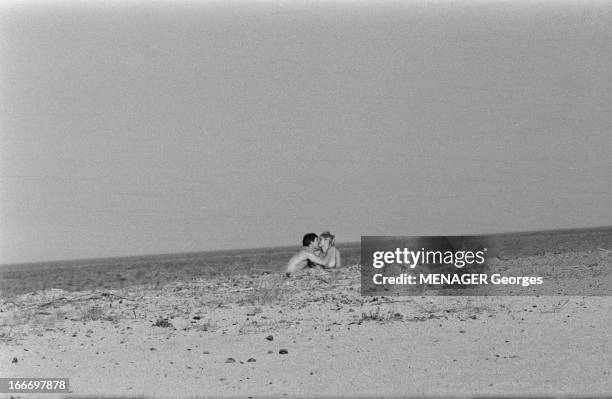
[0,251,612,398]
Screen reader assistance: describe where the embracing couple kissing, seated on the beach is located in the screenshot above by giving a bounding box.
[287,231,342,276]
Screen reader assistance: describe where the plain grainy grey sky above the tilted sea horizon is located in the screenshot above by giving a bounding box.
[0,1,612,263]
